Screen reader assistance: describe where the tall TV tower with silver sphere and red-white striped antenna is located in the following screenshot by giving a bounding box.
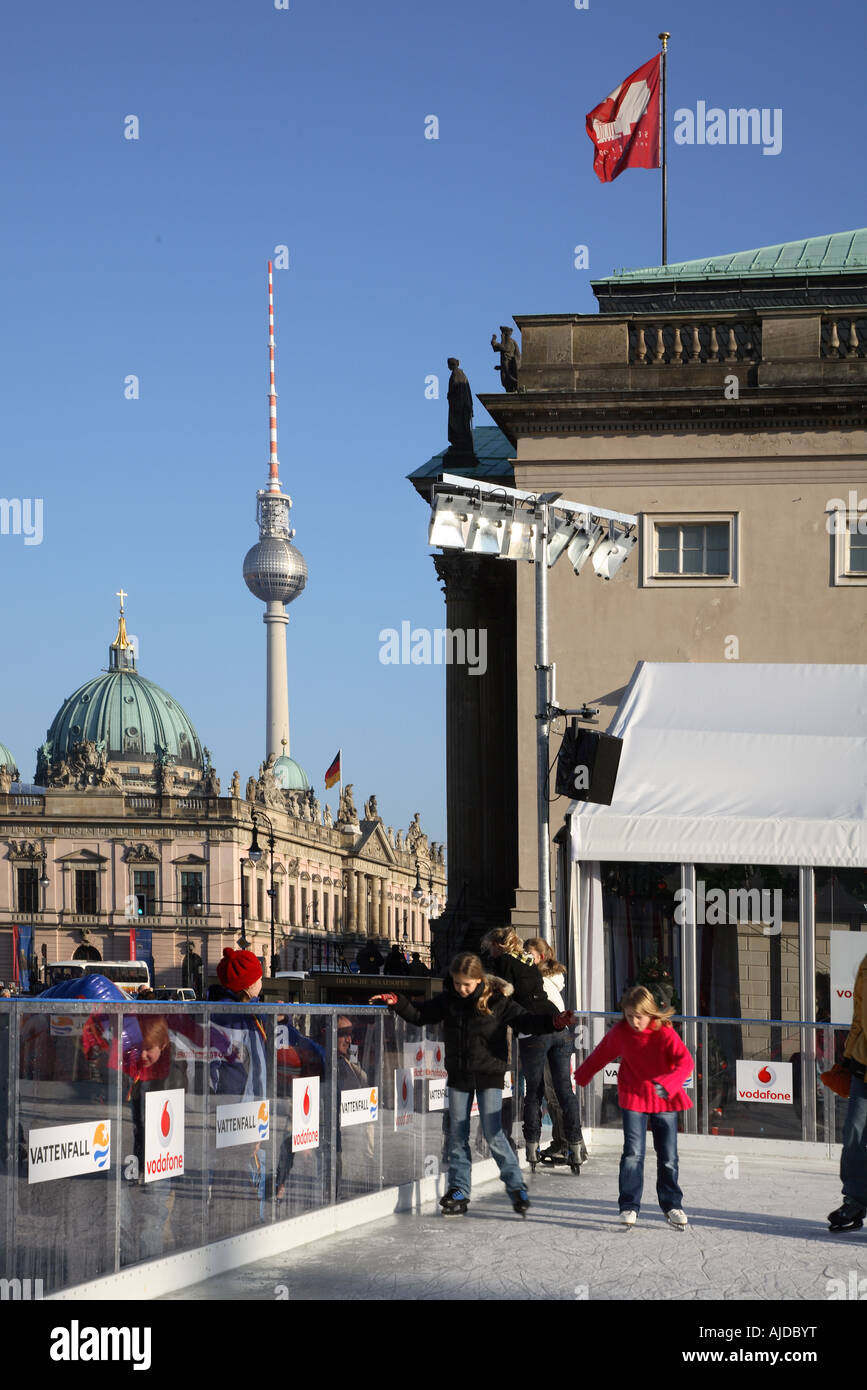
[243,261,307,759]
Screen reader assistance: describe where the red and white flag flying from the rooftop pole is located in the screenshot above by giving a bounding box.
[586,53,660,183]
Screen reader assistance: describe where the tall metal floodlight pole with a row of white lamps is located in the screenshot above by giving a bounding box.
[428,473,638,941]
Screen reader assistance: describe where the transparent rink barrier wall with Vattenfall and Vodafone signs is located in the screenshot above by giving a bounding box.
[0,999,846,1297]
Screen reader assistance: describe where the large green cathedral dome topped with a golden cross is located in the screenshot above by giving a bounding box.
[36,613,204,781]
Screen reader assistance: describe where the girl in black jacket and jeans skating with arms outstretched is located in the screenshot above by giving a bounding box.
[371,954,570,1216]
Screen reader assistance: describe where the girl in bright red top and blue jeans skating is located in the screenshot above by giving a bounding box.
[575,986,693,1230]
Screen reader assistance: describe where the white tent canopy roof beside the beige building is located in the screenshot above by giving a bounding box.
[568,662,867,869]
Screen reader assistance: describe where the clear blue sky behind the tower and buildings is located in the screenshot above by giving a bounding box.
[0,0,866,840]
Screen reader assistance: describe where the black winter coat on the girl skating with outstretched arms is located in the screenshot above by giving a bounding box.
[392,976,554,1091]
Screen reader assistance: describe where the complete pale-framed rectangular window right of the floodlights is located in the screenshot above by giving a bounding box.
[642,513,738,588]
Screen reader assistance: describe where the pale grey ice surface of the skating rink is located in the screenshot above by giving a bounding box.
[167,1148,867,1302]
